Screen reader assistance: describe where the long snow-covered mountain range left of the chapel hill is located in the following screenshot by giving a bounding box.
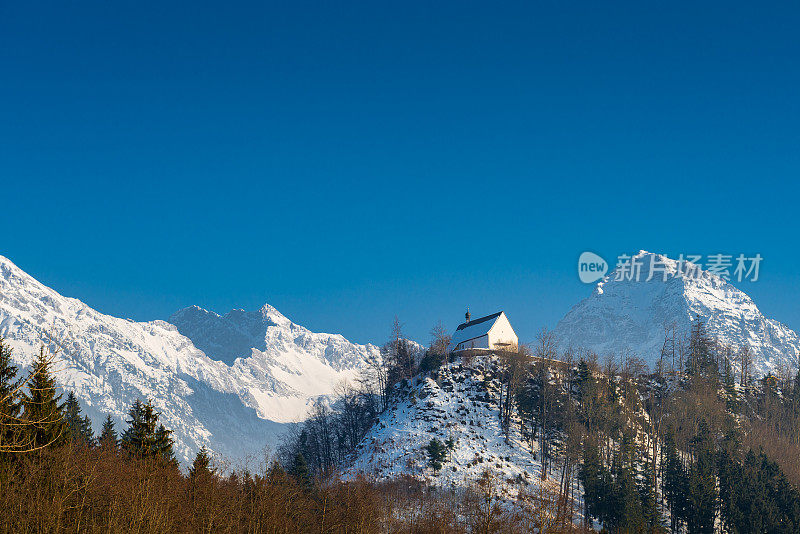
[0,256,379,460]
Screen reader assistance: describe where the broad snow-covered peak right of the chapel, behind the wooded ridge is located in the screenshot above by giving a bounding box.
[555,251,800,374]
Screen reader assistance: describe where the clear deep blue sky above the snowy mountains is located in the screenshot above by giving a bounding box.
[0,2,800,348]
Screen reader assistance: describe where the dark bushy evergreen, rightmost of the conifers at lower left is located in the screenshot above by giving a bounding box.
[122,400,175,463]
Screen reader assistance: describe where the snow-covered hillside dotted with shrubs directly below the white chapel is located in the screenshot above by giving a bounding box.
[346,356,541,497]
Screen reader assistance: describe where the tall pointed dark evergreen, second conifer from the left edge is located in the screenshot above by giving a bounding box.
[23,347,70,449]
